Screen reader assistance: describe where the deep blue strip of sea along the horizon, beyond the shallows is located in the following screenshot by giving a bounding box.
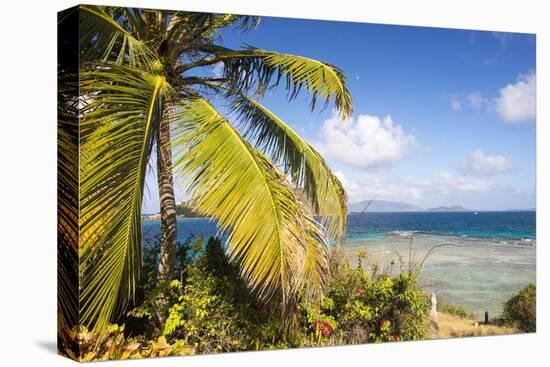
[143,211,536,246]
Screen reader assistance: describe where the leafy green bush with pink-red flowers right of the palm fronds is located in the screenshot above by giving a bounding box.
[303,265,428,344]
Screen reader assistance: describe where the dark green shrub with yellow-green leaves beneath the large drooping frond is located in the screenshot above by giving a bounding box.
[129,238,289,353]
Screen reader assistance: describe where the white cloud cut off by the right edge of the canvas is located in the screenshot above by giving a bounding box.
[495,72,536,122]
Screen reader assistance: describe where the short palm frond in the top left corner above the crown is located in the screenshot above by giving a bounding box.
[80,5,155,68]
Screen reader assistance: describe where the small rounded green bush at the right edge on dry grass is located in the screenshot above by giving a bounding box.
[502,284,537,332]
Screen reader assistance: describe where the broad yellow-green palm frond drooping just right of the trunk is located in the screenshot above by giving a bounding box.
[173,98,312,322]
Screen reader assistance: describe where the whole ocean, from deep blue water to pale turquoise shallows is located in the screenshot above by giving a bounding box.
[143,211,536,317]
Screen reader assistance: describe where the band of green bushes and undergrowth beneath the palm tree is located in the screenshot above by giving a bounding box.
[58,238,434,360]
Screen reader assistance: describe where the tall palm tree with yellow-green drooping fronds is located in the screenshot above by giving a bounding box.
[62,6,352,336]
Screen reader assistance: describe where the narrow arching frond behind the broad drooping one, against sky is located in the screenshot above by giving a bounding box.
[233,94,347,241]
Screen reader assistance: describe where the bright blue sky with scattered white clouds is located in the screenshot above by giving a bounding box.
[143,17,536,213]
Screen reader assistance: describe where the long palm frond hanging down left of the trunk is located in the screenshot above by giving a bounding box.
[80,66,170,327]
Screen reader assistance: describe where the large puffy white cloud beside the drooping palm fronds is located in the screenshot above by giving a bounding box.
[314,115,417,168]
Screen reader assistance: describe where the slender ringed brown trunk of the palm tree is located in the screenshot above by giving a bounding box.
[155,116,177,327]
